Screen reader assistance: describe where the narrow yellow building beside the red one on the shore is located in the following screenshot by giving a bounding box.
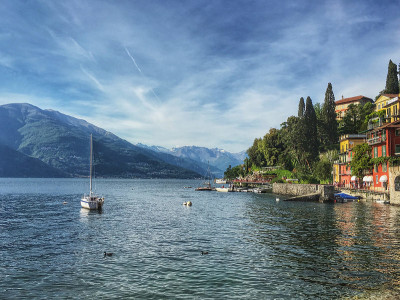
[333,134,366,188]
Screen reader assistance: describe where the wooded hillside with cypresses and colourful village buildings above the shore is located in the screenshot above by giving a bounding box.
[226,60,400,204]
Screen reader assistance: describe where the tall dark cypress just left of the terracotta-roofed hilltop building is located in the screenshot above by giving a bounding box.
[321,82,338,146]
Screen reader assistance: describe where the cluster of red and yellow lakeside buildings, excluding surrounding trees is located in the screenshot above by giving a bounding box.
[333,94,400,202]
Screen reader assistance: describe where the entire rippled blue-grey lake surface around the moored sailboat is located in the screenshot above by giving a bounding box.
[0,178,400,299]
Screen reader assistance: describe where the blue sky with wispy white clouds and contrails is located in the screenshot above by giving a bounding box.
[0,0,400,152]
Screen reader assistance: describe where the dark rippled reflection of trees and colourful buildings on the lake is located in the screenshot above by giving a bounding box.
[245,199,400,295]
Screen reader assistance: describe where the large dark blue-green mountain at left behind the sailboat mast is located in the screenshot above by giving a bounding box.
[0,104,200,178]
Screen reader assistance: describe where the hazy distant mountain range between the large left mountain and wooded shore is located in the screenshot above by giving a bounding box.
[137,144,246,177]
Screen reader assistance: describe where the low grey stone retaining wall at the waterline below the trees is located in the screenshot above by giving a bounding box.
[272,183,334,201]
